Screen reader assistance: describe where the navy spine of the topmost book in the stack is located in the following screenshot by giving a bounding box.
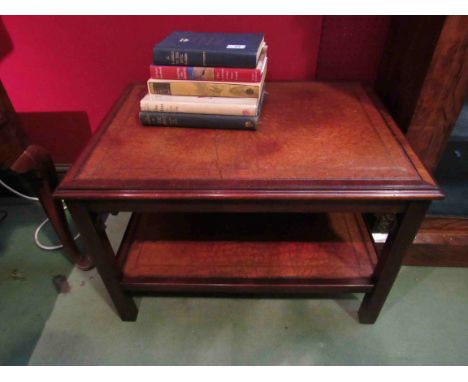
[153,47,257,68]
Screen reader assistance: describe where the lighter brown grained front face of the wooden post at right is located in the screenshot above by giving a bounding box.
[407,16,468,173]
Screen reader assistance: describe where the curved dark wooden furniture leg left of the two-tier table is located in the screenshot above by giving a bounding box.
[11,145,94,270]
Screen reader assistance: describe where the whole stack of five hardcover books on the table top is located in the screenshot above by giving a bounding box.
[140,32,267,130]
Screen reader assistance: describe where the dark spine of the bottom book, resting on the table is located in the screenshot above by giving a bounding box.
[140,111,258,130]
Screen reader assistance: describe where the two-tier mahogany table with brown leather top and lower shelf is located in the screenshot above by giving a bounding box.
[55,82,443,323]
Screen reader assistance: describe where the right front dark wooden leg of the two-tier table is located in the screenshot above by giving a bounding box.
[358,201,430,324]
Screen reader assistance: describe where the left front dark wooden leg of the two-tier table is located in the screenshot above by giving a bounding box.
[67,201,138,321]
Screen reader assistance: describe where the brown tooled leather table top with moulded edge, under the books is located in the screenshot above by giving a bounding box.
[58,82,440,198]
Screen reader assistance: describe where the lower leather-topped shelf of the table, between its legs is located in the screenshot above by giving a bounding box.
[118,213,377,294]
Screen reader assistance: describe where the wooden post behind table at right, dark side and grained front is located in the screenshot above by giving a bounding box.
[375,16,468,173]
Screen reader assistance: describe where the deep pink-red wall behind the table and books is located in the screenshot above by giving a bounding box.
[0,16,388,163]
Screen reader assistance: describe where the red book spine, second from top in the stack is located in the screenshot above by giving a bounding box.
[150,65,262,82]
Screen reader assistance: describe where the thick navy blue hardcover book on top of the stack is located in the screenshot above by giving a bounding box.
[153,32,265,68]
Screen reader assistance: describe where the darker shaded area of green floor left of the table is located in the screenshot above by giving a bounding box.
[0,197,72,365]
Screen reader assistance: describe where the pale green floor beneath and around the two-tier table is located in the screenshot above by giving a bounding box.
[0,200,468,365]
